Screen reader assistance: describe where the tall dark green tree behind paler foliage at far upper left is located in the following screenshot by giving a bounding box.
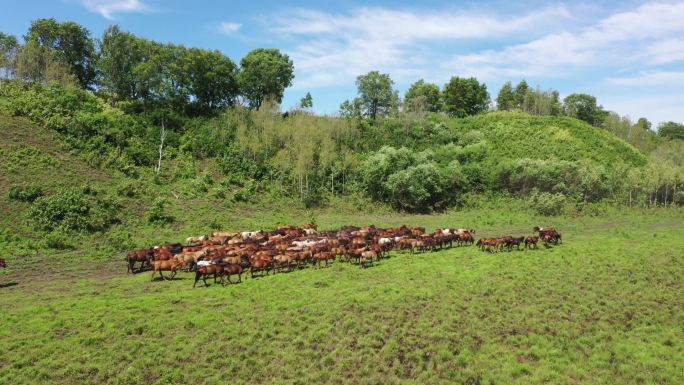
[24,19,96,88]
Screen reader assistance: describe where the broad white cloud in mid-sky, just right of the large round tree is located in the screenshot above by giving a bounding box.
[267,5,571,89]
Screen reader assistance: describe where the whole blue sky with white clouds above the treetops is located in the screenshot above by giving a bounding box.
[0,0,684,126]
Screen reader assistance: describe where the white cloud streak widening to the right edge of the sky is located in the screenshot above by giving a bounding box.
[447,3,684,79]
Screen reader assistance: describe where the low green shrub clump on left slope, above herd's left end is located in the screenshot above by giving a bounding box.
[28,188,119,232]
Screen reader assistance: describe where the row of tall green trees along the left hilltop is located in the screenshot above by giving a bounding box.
[0,19,294,114]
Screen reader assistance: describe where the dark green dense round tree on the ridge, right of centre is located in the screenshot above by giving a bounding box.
[442,76,490,118]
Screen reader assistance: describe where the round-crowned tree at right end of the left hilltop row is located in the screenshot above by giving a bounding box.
[239,48,294,110]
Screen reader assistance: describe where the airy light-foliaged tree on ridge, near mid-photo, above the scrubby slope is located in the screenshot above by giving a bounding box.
[353,71,399,119]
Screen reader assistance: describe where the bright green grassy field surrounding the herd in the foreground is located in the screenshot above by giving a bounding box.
[0,208,684,384]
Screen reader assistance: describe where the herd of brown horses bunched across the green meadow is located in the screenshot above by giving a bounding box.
[126,224,562,287]
